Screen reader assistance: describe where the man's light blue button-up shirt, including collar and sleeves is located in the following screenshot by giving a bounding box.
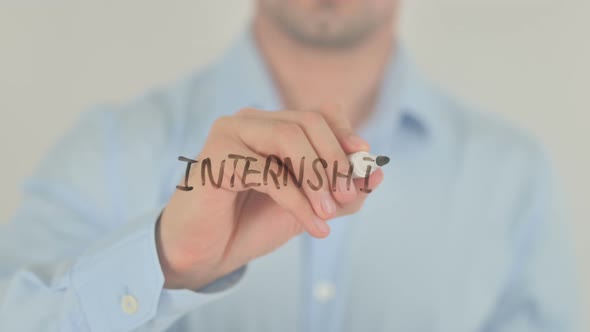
[0,32,577,332]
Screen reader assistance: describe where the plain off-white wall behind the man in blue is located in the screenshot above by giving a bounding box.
[0,0,590,326]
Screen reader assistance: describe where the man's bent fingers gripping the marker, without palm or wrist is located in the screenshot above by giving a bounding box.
[210,106,383,237]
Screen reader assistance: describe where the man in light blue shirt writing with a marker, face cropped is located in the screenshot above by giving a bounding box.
[0,0,575,332]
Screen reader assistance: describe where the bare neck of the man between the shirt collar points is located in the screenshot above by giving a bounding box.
[253,12,394,127]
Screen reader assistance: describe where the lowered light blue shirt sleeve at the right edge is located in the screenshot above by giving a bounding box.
[482,145,582,332]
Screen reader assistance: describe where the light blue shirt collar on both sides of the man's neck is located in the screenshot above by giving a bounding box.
[213,29,439,139]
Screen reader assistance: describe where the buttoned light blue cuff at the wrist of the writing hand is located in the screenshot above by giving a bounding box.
[70,209,246,331]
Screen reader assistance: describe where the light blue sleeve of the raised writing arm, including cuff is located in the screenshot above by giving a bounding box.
[0,105,246,332]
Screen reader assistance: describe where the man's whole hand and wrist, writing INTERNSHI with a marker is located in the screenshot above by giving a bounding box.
[157,107,383,290]
